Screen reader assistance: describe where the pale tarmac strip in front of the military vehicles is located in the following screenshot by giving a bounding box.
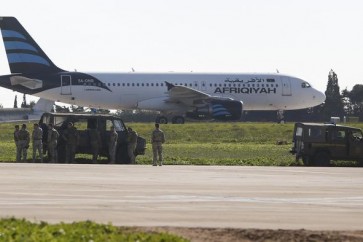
[0,163,363,230]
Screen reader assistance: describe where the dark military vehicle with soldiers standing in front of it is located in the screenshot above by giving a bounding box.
[39,113,146,164]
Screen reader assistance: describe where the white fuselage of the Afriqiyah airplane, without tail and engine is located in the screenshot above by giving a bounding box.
[37,73,325,111]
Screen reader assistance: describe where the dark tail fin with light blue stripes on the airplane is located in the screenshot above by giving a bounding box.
[0,17,62,74]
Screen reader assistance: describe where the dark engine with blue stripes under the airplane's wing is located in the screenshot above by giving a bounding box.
[186,99,243,121]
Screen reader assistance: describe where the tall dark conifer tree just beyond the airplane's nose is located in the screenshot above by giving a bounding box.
[323,70,344,119]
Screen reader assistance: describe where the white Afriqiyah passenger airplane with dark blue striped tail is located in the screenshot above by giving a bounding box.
[0,17,325,123]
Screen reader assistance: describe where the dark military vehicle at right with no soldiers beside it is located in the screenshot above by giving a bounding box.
[290,123,363,166]
